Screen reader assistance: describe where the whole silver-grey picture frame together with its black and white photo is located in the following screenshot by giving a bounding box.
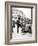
[5,2,37,44]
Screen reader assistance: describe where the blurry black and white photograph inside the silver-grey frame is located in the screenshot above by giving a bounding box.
[10,7,32,42]
